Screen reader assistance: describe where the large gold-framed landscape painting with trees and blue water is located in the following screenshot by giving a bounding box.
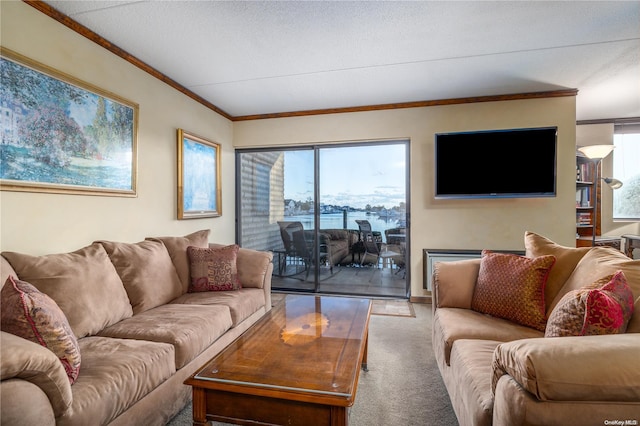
[0,48,138,197]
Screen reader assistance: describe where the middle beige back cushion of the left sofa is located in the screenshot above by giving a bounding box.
[100,240,182,314]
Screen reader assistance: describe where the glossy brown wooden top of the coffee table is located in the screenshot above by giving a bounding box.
[189,295,371,402]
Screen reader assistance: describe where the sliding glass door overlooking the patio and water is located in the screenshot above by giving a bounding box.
[236,140,409,298]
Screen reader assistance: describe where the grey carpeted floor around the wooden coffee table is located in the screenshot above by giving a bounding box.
[168,304,458,426]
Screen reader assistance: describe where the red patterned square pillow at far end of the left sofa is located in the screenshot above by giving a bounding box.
[187,244,242,293]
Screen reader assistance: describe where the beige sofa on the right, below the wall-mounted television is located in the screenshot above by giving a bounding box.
[432,232,640,426]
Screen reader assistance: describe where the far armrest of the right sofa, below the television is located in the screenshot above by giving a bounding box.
[431,259,480,309]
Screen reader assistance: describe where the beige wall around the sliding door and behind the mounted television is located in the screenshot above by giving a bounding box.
[234,97,576,297]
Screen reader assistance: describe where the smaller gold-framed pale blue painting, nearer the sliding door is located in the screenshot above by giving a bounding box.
[178,129,222,219]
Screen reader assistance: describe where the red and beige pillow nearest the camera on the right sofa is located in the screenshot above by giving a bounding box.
[544,271,633,337]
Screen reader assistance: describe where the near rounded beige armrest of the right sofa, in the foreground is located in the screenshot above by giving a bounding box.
[491,333,640,403]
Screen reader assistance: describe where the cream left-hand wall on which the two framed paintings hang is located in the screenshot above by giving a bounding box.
[0,1,235,254]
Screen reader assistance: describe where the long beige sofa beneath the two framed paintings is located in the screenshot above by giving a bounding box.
[0,230,273,426]
